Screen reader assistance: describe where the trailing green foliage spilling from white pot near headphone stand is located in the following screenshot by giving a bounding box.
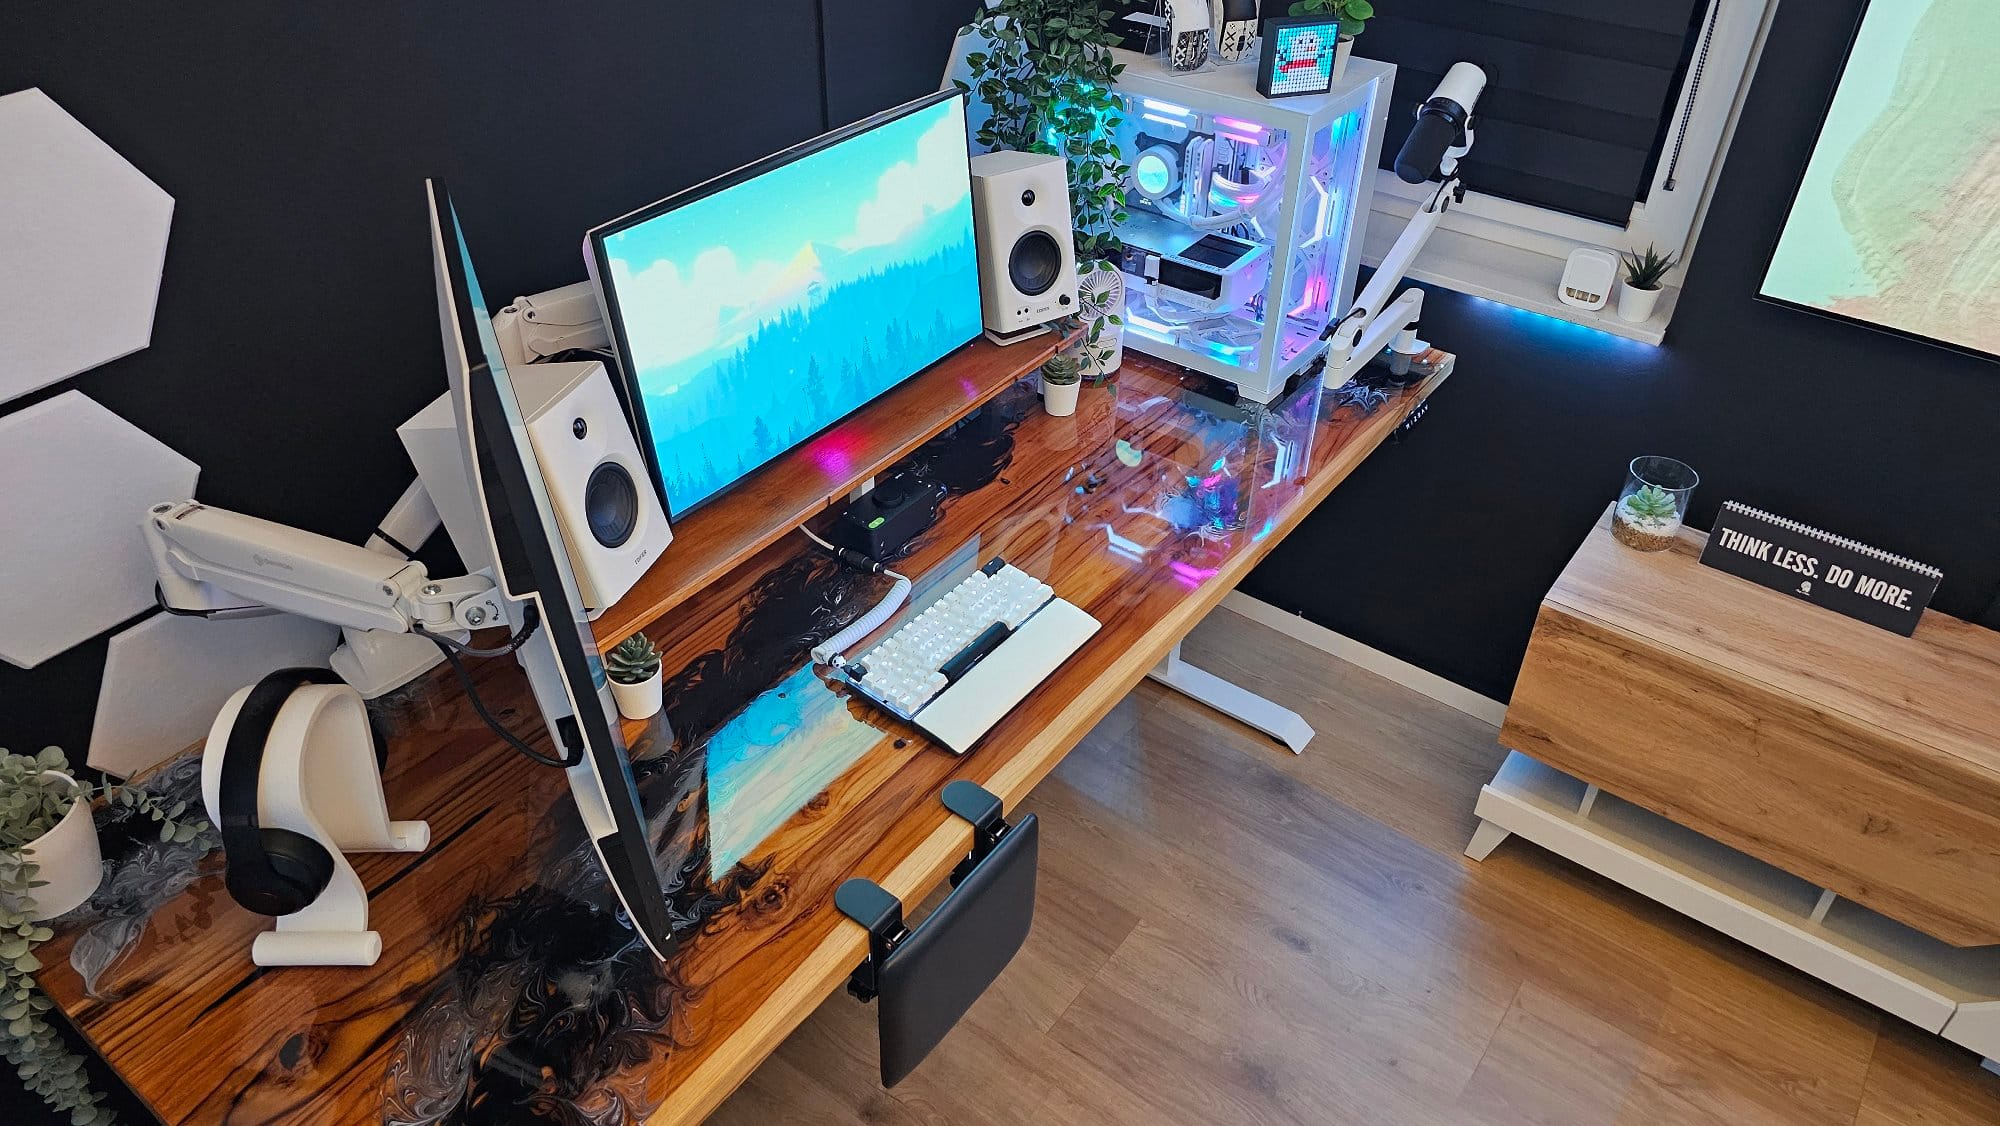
[0,746,212,1126]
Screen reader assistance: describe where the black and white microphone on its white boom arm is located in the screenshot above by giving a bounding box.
[1326,62,1486,388]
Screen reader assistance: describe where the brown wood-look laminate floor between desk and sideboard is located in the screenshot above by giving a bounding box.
[714,610,2000,1126]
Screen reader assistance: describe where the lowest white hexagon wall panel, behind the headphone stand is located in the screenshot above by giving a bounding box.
[90,614,340,776]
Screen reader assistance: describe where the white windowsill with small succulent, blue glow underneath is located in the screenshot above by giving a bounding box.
[1362,210,1680,344]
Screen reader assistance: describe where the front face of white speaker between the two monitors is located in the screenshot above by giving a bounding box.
[508,362,674,618]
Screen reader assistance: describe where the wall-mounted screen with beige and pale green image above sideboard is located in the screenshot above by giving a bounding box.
[1764,0,2000,354]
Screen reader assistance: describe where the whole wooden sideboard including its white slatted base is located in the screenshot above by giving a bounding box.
[1468,512,2000,1058]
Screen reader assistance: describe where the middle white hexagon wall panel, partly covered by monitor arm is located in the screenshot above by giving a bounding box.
[0,390,200,668]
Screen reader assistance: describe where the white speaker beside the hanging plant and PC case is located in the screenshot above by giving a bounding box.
[972,152,1076,344]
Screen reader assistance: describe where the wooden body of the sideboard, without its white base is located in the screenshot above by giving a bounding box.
[1500,510,2000,946]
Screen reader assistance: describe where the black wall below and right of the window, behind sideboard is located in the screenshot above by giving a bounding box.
[1246,0,2000,700]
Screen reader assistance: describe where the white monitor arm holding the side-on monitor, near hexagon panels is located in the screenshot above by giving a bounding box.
[142,484,508,696]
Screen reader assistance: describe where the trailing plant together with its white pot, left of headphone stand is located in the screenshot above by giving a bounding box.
[0,746,212,1126]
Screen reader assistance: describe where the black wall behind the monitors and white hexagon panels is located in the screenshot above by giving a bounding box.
[0,0,966,758]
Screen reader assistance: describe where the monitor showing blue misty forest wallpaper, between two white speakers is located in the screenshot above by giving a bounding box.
[600,98,980,516]
